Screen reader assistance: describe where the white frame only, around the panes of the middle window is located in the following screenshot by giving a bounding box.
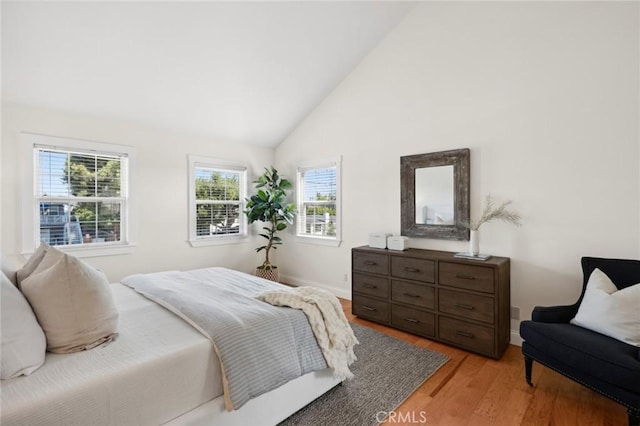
[188,154,249,247]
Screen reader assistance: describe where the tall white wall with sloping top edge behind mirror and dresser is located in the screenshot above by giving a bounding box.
[276,2,640,336]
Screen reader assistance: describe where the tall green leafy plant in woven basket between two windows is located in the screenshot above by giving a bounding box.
[244,166,296,281]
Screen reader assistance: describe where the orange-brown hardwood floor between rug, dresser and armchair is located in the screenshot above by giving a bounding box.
[341,299,627,426]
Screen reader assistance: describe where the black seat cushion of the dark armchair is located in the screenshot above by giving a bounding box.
[520,321,640,393]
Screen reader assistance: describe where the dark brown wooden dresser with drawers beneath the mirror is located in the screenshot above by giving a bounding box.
[351,246,511,359]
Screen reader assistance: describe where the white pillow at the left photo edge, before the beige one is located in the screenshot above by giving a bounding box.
[0,274,47,379]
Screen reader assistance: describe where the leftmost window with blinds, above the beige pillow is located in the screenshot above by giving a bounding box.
[23,135,134,256]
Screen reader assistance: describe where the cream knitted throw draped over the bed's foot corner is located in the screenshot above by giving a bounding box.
[258,287,359,380]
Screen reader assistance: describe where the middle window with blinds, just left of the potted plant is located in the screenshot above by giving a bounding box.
[189,156,247,247]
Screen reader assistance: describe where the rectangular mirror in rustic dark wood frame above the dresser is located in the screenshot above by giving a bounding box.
[400,149,470,240]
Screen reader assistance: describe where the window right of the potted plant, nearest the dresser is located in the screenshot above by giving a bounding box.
[296,158,342,246]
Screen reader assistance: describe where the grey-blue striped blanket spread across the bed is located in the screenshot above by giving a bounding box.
[122,268,327,410]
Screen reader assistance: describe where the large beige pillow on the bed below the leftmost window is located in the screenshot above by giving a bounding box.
[22,248,118,353]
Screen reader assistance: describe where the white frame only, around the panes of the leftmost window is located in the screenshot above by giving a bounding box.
[20,133,137,257]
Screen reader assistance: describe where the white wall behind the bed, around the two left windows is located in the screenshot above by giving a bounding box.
[1,103,273,281]
